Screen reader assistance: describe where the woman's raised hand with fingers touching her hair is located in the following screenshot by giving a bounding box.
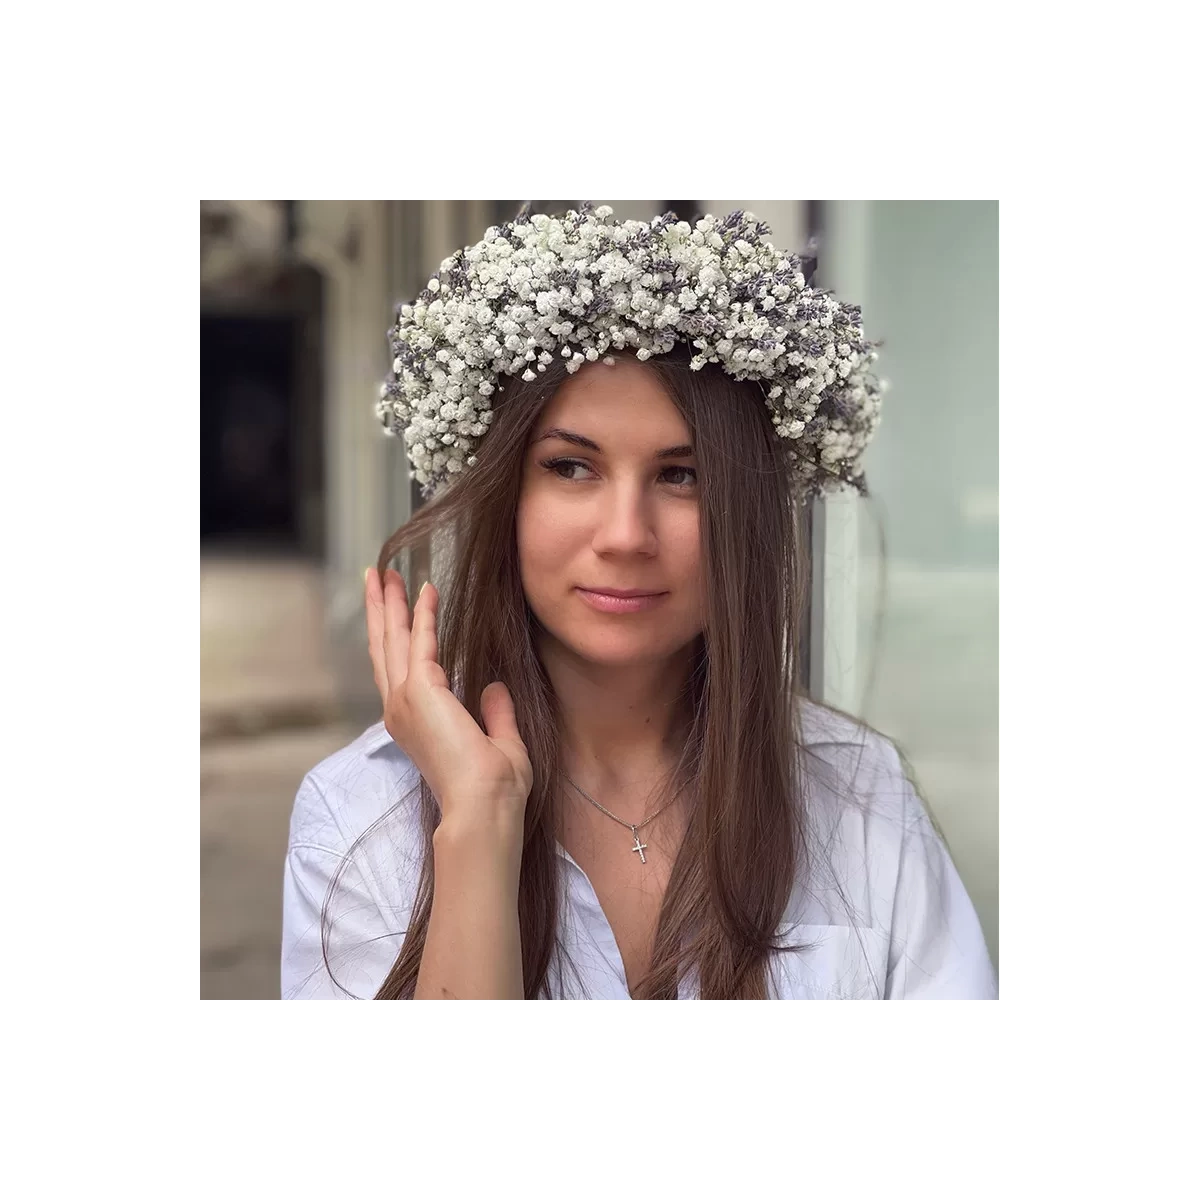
[366,566,533,827]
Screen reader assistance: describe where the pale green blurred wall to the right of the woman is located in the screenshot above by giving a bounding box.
[844,200,998,960]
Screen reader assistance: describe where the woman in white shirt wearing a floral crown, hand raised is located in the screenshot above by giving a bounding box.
[282,209,995,1000]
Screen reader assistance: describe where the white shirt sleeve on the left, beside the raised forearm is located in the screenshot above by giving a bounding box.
[280,775,407,1000]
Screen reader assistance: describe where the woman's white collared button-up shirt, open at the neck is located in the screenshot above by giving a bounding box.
[281,704,996,1000]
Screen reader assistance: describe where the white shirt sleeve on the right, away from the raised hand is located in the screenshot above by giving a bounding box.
[884,749,997,1000]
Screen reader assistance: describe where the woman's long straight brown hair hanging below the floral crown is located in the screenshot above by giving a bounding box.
[322,347,864,1000]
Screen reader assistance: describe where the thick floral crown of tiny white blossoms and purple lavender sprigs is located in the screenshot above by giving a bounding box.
[376,204,886,499]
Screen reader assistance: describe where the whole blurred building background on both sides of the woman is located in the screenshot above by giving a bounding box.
[200,199,1000,1000]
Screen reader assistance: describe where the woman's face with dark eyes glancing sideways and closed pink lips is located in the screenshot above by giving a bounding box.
[517,359,703,666]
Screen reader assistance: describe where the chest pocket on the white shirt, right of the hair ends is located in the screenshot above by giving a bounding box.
[769,924,888,1000]
